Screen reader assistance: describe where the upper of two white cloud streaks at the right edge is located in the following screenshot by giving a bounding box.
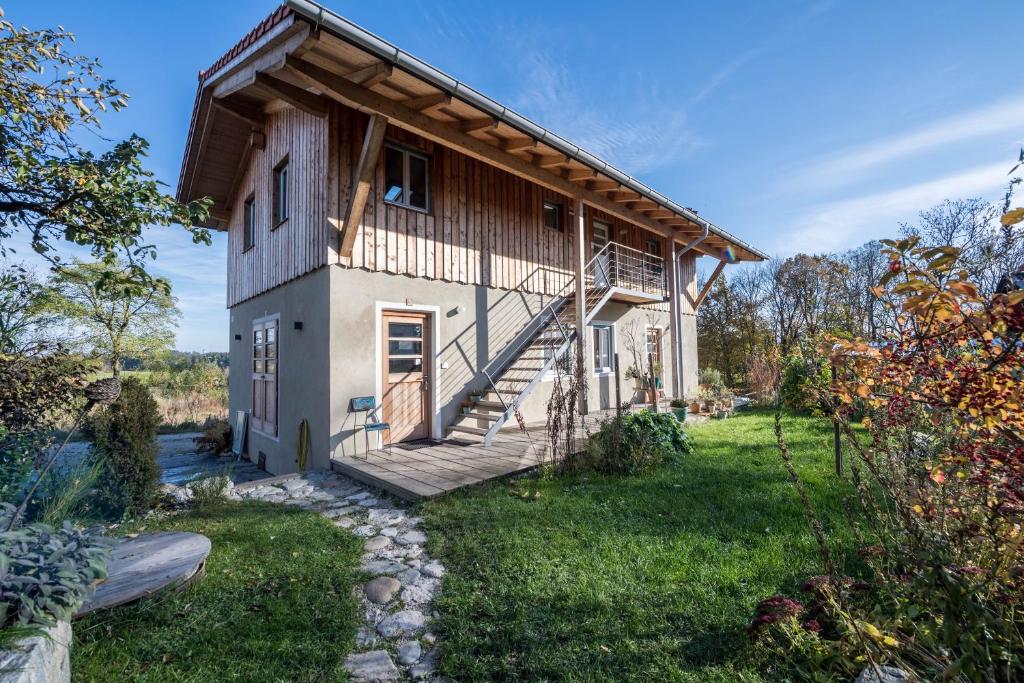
[791,95,1024,190]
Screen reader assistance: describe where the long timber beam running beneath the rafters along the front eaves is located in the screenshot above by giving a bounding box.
[285,55,718,257]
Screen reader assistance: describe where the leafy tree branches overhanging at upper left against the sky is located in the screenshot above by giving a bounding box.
[0,11,210,285]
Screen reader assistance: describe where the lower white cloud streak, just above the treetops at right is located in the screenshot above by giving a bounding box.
[774,161,1007,255]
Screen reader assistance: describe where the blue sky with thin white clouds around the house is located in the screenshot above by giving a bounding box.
[4,0,1024,350]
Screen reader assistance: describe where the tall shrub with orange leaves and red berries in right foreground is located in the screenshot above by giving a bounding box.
[755,232,1024,681]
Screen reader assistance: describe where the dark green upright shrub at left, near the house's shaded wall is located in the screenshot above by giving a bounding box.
[84,377,160,514]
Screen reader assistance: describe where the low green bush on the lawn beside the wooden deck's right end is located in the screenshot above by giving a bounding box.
[578,410,693,474]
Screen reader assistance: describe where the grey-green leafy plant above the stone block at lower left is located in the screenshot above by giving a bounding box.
[0,504,110,629]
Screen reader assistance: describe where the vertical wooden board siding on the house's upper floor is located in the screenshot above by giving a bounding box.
[227,104,696,311]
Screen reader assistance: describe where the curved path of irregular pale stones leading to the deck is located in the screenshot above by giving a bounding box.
[229,472,450,683]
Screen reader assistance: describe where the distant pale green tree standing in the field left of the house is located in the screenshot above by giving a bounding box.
[53,261,180,377]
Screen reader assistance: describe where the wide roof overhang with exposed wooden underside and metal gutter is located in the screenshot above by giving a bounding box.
[178,0,767,262]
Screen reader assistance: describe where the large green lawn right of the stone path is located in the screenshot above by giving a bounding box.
[424,412,853,681]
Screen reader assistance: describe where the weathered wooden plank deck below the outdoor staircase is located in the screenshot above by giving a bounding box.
[331,429,545,501]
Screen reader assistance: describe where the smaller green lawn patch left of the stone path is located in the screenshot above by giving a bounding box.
[72,502,361,682]
